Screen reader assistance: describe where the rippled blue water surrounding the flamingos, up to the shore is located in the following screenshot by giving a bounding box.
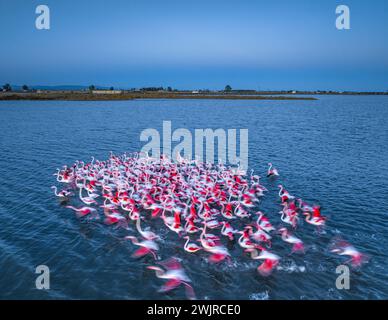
[0,96,388,299]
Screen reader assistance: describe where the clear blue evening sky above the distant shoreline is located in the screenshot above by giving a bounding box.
[0,0,388,90]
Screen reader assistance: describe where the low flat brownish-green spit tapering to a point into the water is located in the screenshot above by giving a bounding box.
[0,91,317,101]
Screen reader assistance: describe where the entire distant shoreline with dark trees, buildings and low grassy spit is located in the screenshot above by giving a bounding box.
[0,83,388,101]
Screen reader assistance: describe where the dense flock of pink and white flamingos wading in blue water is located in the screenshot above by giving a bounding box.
[52,152,365,299]
